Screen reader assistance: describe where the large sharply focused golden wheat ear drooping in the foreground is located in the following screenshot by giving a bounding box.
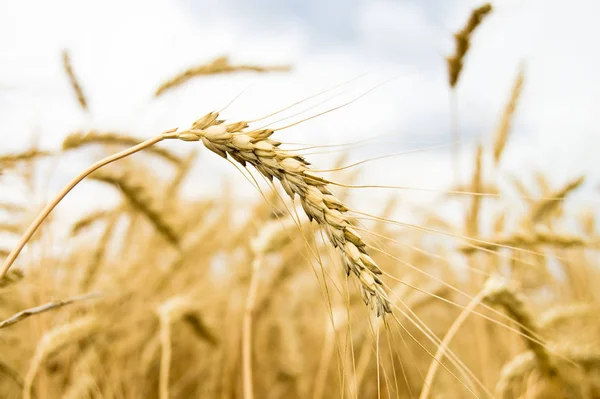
[166,112,392,315]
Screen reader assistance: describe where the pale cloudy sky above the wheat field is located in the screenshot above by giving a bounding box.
[0,0,600,227]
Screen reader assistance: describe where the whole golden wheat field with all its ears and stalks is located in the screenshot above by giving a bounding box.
[0,5,600,399]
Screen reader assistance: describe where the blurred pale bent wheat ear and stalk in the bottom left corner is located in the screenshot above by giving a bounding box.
[23,315,100,399]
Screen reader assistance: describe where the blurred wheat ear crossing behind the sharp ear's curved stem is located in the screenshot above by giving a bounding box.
[62,130,182,166]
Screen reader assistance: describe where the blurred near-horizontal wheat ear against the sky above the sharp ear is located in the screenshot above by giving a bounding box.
[154,57,290,97]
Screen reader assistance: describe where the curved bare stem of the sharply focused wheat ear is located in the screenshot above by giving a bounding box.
[0,131,166,280]
